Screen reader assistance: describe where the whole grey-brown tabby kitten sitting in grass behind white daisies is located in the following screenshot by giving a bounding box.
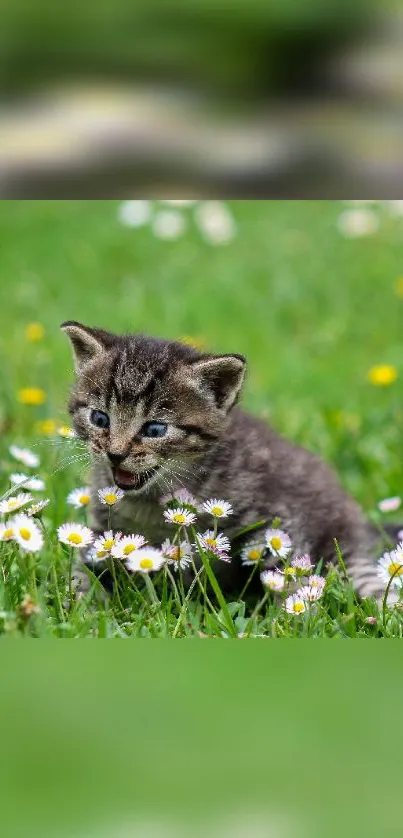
[62,321,392,598]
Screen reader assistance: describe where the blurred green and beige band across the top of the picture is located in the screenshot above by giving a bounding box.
[0,0,403,198]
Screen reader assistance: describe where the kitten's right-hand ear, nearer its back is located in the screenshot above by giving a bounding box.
[192,355,246,413]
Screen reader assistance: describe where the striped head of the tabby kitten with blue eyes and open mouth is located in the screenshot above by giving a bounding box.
[62,321,245,492]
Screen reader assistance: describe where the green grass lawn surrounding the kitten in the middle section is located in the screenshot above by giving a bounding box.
[0,201,403,637]
